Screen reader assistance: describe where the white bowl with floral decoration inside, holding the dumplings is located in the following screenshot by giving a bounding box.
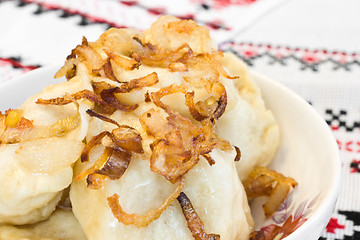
[0,66,341,240]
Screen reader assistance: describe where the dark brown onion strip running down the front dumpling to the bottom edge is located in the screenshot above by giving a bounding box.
[177,192,220,240]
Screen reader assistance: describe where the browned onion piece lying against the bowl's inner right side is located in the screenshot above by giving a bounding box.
[243,167,297,217]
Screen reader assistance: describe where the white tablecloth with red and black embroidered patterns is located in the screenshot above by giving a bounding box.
[0,0,360,240]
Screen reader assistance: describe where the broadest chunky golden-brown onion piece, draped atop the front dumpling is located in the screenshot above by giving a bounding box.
[140,106,208,182]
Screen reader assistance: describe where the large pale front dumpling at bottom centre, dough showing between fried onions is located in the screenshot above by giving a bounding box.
[70,107,253,240]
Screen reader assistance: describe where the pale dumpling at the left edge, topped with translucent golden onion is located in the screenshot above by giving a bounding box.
[0,63,91,225]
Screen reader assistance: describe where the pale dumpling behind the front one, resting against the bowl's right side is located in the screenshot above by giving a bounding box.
[217,53,280,181]
